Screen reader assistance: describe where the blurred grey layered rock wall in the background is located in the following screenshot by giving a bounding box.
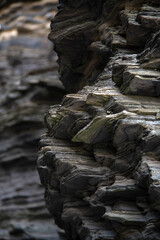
[0,0,64,240]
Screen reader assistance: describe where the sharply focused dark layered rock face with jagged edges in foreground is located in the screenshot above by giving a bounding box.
[38,0,160,240]
